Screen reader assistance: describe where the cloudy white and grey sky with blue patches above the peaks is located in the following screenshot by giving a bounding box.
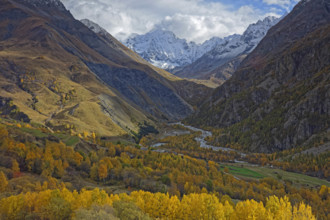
[62,0,299,43]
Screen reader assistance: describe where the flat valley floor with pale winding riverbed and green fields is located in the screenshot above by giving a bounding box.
[151,122,330,187]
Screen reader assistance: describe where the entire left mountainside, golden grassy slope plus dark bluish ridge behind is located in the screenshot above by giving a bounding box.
[0,0,210,138]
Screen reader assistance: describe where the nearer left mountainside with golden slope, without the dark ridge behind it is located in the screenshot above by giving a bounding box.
[0,1,155,136]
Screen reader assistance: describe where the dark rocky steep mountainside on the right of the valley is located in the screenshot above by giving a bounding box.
[187,0,330,152]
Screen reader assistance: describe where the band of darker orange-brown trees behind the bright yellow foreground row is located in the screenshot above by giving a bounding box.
[0,123,330,219]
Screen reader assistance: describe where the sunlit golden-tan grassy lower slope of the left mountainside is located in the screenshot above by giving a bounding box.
[0,47,147,136]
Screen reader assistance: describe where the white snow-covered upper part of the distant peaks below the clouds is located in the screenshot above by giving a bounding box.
[123,17,279,69]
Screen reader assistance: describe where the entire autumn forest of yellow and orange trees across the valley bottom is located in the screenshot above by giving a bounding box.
[0,119,330,219]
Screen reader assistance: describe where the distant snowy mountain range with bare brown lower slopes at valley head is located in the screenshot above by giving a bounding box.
[124,16,280,83]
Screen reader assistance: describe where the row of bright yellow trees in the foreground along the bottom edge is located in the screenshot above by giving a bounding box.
[0,188,315,220]
